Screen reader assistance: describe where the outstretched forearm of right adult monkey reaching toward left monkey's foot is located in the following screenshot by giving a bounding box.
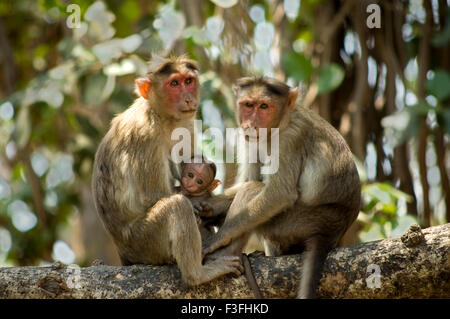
[204,143,302,254]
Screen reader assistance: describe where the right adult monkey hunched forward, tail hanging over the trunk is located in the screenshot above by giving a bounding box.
[203,77,361,298]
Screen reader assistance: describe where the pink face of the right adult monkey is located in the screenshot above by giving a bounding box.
[238,98,278,139]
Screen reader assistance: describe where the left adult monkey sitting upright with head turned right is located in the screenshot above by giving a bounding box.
[92,56,241,285]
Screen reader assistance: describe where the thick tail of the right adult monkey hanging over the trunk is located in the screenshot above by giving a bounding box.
[297,235,331,299]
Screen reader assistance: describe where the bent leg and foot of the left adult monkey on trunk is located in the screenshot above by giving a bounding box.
[119,194,242,285]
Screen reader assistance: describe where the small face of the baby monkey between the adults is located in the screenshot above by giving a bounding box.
[181,164,214,195]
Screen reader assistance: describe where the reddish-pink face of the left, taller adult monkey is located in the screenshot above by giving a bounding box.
[163,73,198,119]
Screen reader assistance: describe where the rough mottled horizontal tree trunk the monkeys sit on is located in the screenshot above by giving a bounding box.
[0,224,450,298]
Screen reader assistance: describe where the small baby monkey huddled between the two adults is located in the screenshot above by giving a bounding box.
[177,156,234,240]
